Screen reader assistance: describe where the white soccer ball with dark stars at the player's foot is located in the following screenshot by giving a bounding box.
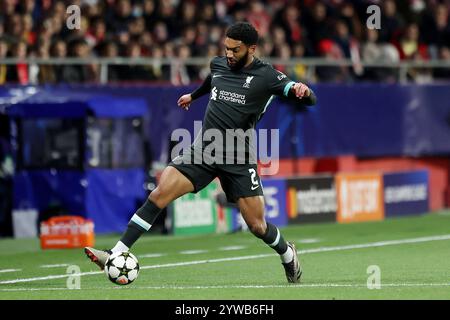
[105,252,139,285]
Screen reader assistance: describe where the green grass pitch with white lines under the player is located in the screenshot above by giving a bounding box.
[0,211,450,300]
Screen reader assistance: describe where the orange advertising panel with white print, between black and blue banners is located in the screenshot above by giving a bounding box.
[336,173,384,223]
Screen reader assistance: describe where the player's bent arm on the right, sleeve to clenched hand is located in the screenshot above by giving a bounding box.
[266,67,317,106]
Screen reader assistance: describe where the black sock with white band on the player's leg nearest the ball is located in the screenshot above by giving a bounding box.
[120,199,162,248]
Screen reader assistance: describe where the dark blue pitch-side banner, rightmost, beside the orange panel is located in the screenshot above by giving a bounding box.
[383,170,429,217]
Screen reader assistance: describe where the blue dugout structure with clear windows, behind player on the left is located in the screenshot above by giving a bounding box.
[8,90,148,233]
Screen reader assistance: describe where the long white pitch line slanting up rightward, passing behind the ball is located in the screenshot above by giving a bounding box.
[0,234,450,284]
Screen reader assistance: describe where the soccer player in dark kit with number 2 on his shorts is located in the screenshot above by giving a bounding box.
[85,22,316,283]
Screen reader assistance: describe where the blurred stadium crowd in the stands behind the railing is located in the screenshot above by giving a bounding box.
[0,0,450,85]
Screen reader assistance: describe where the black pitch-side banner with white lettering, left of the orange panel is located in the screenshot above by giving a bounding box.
[286,175,336,223]
